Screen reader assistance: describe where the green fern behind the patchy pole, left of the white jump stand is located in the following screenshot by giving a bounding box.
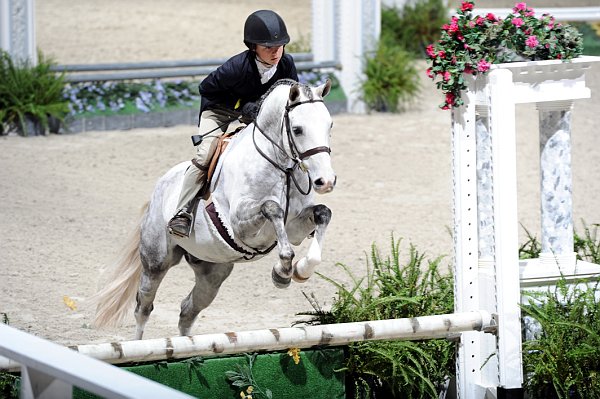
[301,236,455,398]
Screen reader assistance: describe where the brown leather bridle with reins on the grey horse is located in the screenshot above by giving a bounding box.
[252,99,331,223]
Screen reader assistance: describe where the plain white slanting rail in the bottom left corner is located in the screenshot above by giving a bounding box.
[0,323,192,399]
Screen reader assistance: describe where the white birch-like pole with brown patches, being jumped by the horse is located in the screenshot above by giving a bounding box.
[0,311,496,369]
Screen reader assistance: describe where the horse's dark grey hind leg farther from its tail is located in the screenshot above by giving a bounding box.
[179,255,233,335]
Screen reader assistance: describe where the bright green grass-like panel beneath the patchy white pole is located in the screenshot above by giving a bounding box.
[73,348,346,399]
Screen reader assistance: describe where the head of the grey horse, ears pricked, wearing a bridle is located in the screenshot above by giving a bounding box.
[283,80,336,194]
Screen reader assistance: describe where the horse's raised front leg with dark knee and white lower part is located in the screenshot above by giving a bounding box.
[293,204,331,283]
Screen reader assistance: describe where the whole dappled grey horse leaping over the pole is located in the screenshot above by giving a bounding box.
[94,80,336,339]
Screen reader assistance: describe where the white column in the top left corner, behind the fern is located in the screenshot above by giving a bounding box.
[0,0,37,63]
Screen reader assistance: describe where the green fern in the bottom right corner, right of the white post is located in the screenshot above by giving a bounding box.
[521,279,600,399]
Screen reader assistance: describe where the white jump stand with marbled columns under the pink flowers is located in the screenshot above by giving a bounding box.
[452,57,600,398]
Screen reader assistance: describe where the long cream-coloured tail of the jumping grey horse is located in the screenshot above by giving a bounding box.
[92,204,148,328]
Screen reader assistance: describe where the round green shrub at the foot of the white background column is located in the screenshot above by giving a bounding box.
[362,41,420,112]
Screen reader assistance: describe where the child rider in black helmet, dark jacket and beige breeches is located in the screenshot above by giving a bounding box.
[168,10,298,237]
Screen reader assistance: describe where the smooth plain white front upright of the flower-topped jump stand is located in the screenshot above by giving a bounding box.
[489,69,523,390]
